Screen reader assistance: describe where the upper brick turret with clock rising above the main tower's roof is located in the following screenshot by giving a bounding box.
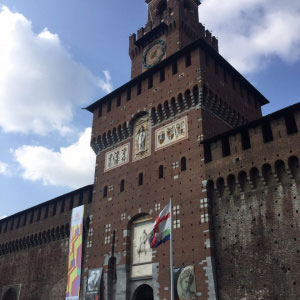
[129,0,218,78]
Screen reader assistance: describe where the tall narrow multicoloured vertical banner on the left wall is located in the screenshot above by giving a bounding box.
[66,205,84,300]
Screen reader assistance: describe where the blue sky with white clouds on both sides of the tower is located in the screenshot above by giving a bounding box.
[0,0,300,217]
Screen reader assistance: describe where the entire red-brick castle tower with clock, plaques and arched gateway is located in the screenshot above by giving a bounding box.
[84,0,268,300]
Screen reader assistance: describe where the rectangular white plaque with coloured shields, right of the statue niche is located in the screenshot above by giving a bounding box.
[155,116,188,151]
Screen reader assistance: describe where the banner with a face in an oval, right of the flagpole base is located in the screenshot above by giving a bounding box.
[173,266,197,300]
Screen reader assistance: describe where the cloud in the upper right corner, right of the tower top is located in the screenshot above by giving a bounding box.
[199,0,300,73]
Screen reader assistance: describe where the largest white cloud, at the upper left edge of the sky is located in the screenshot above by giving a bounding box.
[0,6,112,135]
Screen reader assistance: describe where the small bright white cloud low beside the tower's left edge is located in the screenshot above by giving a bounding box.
[14,128,96,188]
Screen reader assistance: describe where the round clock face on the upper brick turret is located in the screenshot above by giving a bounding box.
[142,40,166,69]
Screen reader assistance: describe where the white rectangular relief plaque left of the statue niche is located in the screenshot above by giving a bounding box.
[104,143,130,172]
